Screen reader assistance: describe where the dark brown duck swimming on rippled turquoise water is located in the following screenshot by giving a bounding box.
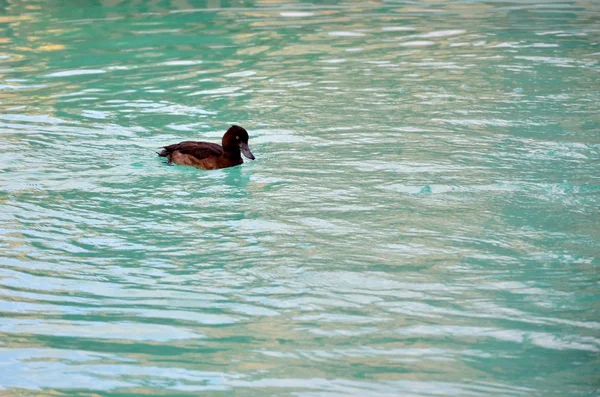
[157,125,255,170]
